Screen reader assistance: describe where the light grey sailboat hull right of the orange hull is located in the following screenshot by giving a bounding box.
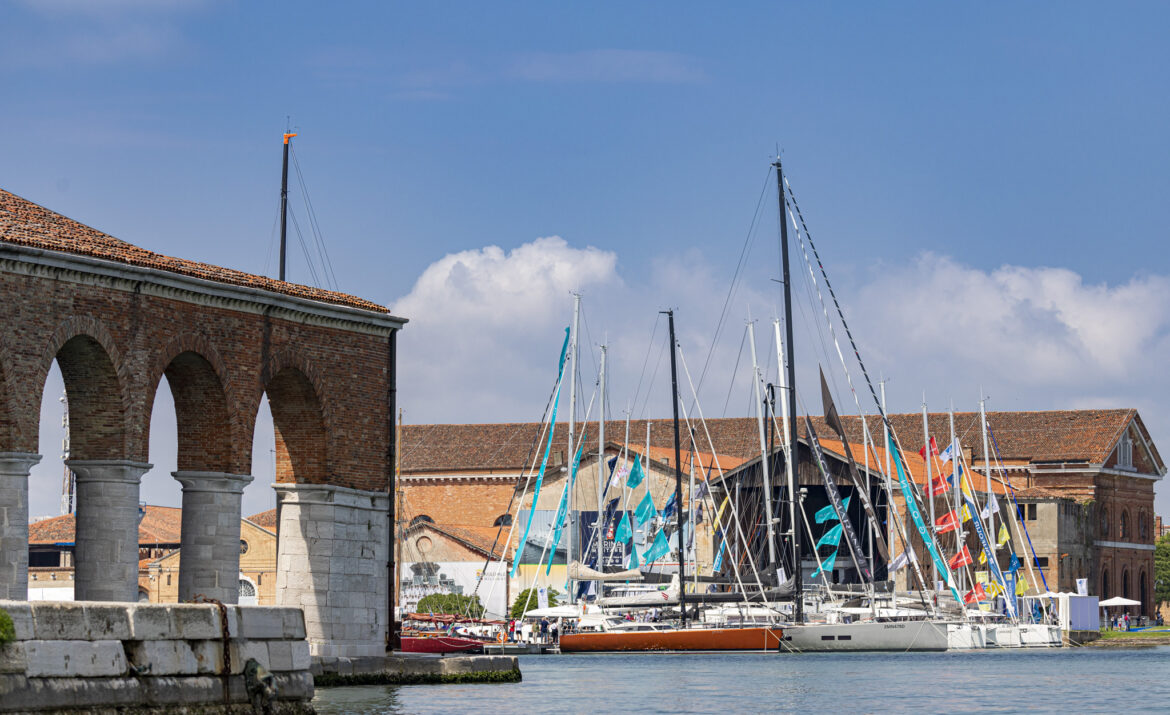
[784,620,948,653]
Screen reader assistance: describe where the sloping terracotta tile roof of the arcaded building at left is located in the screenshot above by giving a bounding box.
[0,190,390,312]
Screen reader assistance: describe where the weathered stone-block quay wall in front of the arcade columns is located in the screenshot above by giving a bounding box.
[0,600,314,714]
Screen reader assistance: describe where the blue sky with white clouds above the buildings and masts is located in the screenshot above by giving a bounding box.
[0,0,1170,514]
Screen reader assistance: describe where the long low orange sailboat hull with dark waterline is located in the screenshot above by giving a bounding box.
[560,627,784,653]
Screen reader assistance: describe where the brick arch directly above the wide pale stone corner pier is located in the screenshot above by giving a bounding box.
[253,353,331,483]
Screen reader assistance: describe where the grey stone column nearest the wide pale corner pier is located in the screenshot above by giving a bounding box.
[171,472,252,604]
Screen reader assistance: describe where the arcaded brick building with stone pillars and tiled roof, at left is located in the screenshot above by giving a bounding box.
[0,191,405,656]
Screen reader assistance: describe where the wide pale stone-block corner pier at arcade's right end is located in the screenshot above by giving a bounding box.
[273,483,390,660]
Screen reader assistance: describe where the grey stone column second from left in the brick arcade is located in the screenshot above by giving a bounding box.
[66,460,152,601]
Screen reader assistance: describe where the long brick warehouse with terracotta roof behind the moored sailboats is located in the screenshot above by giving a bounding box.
[400,410,1165,614]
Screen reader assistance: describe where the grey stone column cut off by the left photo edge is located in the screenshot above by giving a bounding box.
[0,452,41,600]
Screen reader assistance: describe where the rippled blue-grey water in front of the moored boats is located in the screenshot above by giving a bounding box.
[314,646,1170,715]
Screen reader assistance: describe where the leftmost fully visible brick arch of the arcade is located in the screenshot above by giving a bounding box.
[40,317,130,460]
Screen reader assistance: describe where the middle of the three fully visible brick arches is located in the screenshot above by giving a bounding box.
[145,335,239,472]
